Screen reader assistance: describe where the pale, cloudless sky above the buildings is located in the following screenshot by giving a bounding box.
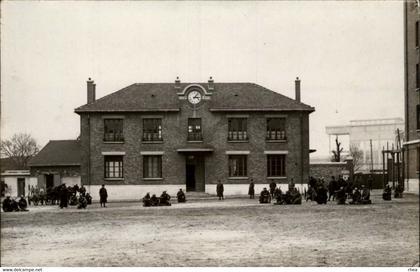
[1,1,404,156]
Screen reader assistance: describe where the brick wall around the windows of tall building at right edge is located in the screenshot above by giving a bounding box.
[404,1,420,193]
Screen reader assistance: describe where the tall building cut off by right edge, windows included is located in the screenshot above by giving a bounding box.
[403,1,420,193]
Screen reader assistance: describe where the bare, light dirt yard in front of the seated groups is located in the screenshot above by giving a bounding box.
[1,192,419,266]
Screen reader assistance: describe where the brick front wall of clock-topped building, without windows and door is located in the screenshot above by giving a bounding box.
[81,101,309,190]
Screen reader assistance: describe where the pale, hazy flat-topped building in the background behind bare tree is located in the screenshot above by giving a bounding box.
[325,118,404,173]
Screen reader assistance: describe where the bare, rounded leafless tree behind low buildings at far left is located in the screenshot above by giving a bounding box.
[0,133,39,169]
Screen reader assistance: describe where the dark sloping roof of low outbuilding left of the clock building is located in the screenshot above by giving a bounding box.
[29,140,81,167]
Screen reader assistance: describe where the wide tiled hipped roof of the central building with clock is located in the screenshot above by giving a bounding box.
[75,83,315,113]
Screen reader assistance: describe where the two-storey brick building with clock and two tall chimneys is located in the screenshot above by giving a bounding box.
[75,78,314,199]
